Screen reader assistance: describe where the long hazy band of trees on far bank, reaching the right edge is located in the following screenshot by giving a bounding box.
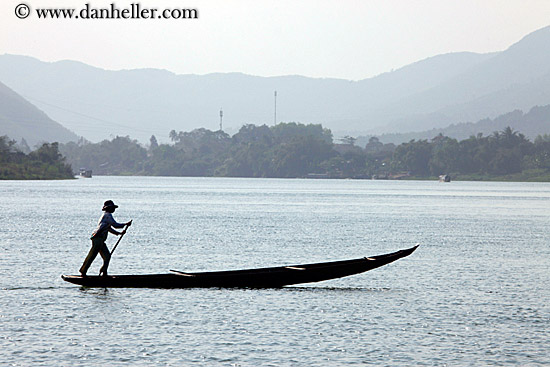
[60,123,550,181]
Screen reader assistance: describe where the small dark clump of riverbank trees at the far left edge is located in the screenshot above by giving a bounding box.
[0,136,74,180]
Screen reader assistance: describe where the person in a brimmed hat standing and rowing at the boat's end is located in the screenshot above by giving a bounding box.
[80,200,132,276]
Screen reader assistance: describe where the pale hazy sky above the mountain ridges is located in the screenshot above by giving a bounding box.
[0,0,550,80]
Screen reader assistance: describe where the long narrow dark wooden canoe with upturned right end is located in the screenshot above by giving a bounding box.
[61,245,418,288]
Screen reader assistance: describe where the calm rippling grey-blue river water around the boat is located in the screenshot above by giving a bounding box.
[0,177,550,366]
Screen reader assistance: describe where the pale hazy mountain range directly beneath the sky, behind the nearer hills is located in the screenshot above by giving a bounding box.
[0,27,550,142]
